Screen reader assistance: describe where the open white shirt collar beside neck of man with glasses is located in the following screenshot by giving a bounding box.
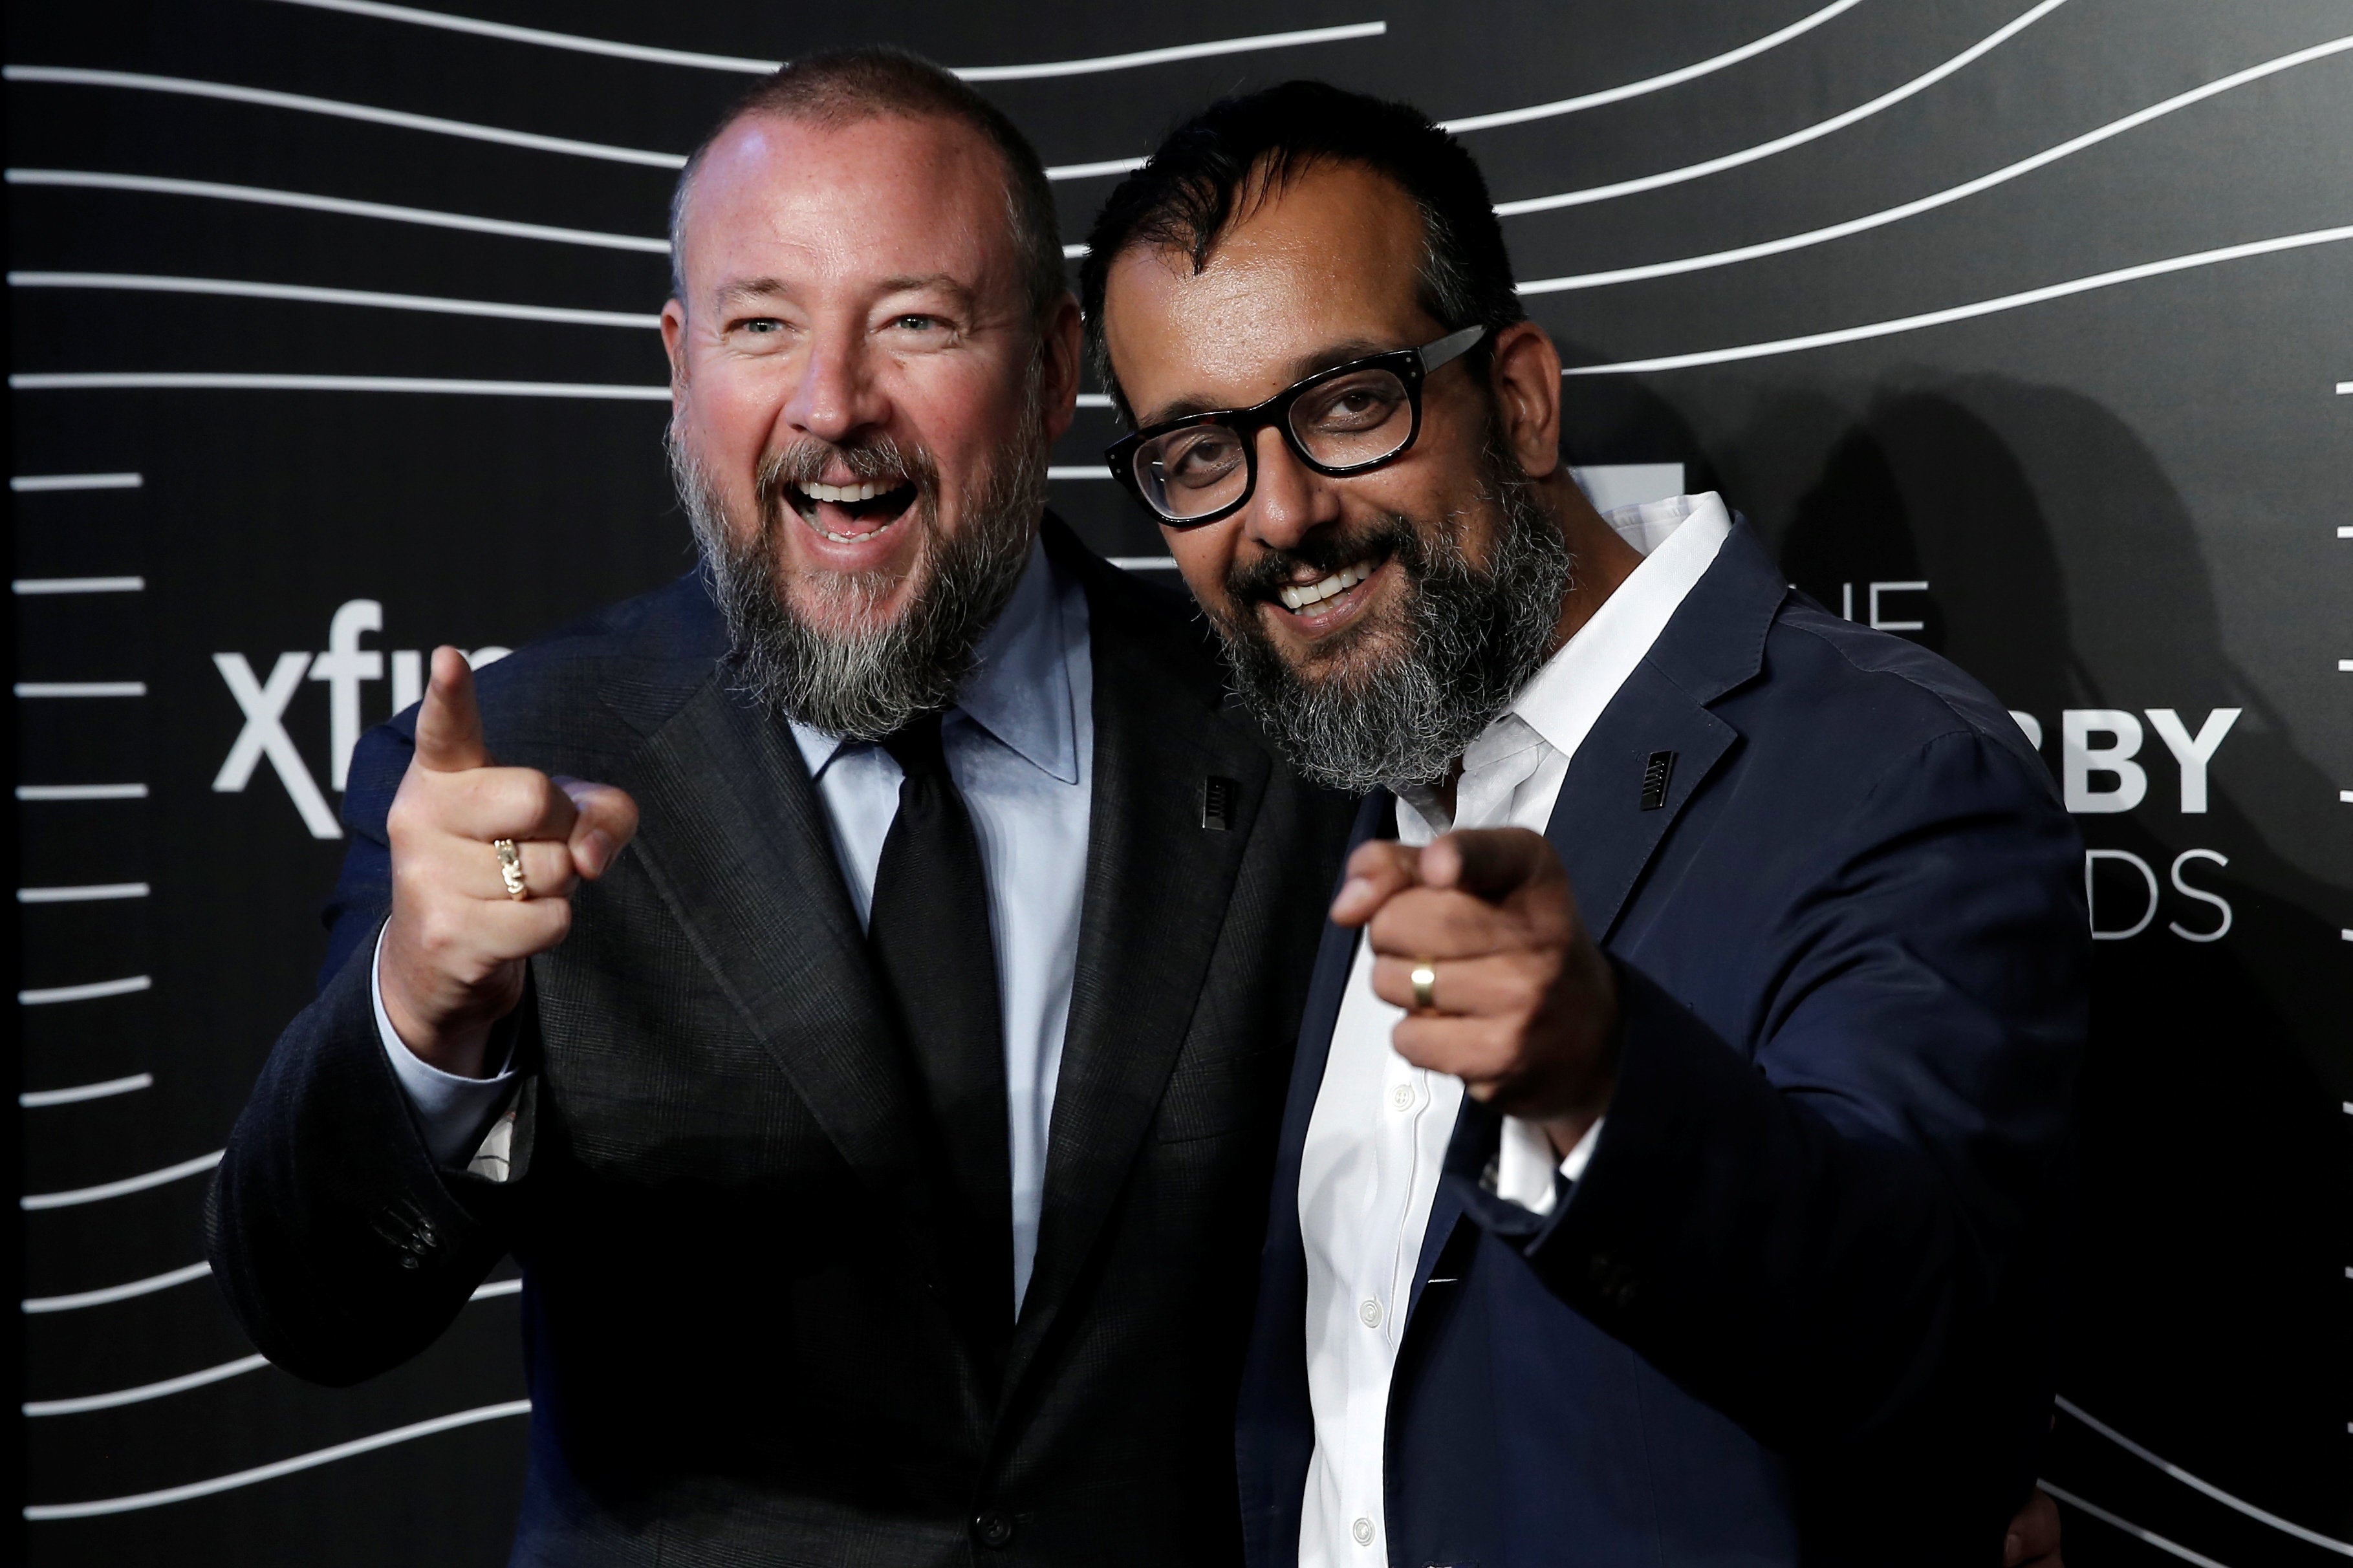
[1482,491,1732,757]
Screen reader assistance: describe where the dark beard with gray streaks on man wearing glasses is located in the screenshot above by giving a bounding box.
[1209,444,1574,795]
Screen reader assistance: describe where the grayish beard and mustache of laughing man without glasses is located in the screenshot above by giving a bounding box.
[668,392,1047,740]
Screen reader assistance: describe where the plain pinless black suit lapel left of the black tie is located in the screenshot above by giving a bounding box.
[614,680,955,1269]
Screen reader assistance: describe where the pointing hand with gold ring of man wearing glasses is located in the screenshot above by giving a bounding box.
[1332,828,1616,1152]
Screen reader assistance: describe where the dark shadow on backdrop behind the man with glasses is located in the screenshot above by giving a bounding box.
[1565,369,2353,1568]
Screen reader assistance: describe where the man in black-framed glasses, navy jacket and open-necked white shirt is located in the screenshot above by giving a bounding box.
[1082,82,2087,1568]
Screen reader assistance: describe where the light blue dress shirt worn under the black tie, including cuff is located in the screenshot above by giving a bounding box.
[374,543,1094,1312]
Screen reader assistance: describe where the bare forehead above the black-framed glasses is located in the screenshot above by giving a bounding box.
[1103,164,1438,423]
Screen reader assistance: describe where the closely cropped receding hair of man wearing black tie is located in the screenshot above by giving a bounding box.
[671,47,1068,317]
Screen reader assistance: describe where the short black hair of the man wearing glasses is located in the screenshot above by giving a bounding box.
[1078,82,1527,416]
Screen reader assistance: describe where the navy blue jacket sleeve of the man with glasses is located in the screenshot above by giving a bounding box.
[1523,733,2090,1450]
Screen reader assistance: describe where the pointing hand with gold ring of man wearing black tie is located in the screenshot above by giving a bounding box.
[379,649,638,1079]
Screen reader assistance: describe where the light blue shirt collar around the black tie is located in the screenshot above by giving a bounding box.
[793,541,1082,783]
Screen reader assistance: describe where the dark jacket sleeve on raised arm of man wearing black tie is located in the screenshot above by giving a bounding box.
[205,729,532,1384]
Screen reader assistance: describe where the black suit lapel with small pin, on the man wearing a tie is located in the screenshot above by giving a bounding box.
[1004,522,1271,1391]
